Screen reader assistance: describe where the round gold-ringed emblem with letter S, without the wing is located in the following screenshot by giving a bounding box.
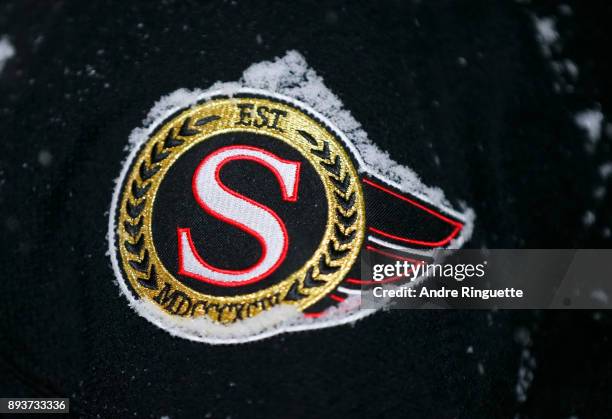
[111,94,365,326]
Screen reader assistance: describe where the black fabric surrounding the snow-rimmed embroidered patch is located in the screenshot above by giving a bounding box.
[0,0,612,418]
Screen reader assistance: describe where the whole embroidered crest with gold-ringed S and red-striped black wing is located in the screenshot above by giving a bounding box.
[109,51,469,343]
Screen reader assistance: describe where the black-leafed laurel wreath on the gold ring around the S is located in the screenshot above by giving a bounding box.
[118,96,364,323]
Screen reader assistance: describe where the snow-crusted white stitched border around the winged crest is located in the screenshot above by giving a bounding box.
[107,51,474,344]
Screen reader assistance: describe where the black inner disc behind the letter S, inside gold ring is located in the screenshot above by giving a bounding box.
[152,132,328,295]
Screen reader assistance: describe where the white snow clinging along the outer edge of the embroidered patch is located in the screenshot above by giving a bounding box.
[108,51,475,343]
